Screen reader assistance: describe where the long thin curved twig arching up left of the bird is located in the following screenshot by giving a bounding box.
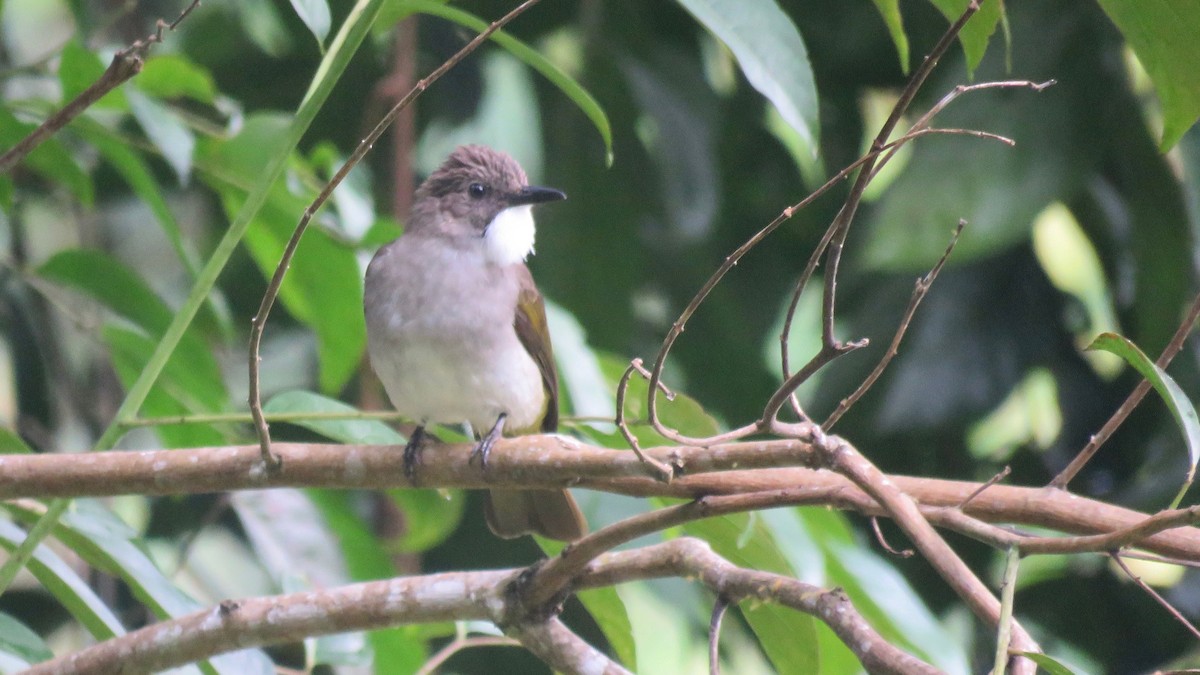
[248,0,538,471]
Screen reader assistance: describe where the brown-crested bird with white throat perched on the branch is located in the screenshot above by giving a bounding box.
[364,145,587,542]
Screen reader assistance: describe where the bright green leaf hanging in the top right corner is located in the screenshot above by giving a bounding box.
[1099,0,1200,153]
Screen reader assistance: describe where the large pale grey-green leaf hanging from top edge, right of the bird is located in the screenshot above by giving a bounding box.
[678,0,821,148]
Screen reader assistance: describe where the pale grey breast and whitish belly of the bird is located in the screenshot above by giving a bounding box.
[366,237,546,432]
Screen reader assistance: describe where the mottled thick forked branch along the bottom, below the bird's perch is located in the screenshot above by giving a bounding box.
[26,538,937,675]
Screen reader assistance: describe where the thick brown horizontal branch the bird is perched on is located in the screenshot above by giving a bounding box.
[7,436,1200,561]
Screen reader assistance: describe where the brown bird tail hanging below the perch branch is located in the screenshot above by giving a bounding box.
[484,490,588,542]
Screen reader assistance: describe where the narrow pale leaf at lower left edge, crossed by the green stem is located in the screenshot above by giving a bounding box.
[0,520,125,640]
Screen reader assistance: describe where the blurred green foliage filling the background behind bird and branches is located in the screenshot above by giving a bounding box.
[0,0,1200,674]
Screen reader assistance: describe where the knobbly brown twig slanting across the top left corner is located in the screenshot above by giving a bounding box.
[0,0,200,174]
